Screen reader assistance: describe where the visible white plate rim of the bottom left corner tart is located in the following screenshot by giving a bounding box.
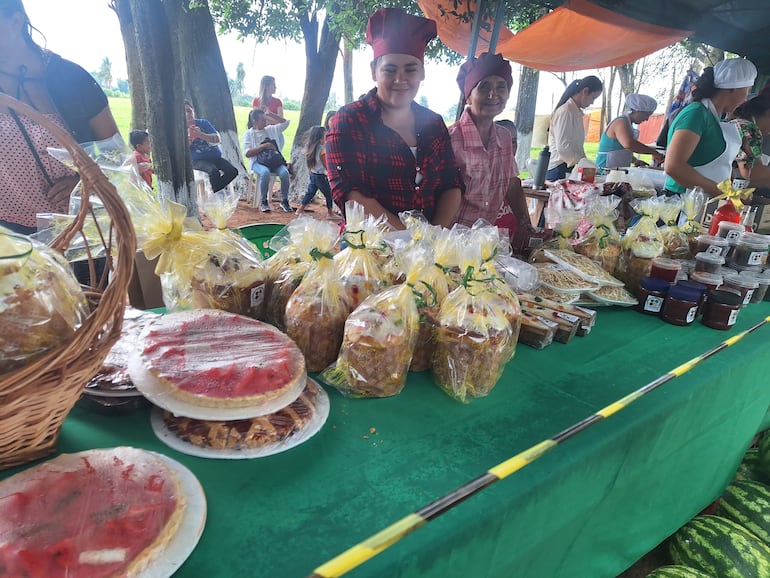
[140,452,206,578]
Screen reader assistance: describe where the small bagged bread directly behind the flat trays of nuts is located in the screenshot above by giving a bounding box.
[574,195,622,274]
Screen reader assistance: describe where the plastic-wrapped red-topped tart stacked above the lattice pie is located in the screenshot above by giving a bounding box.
[132,309,307,410]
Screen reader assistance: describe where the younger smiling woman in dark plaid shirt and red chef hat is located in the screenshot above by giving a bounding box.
[326,8,461,229]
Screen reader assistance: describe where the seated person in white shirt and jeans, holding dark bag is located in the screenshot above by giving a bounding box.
[243,108,294,213]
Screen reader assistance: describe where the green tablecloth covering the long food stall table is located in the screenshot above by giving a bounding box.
[6,303,770,578]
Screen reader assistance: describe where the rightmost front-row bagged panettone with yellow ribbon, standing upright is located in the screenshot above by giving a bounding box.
[432,238,516,403]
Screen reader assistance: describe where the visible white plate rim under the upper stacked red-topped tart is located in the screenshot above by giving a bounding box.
[128,351,305,421]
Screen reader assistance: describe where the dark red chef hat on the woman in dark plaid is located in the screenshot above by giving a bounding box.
[366,8,437,60]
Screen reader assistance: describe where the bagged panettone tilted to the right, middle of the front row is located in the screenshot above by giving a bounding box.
[323,245,424,397]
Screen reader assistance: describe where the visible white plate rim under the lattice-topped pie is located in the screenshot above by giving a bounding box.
[150,378,329,460]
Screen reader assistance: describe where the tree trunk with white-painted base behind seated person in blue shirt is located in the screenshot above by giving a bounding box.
[176,0,248,193]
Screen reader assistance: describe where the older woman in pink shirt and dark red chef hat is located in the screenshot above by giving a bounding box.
[449,52,532,243]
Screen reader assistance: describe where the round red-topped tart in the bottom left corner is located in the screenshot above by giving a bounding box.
[0,447,195,578]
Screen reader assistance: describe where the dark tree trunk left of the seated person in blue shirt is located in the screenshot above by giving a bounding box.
[128,0,198,212]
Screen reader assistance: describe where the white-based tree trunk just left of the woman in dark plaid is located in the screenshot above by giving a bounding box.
[290,6,340,200]
